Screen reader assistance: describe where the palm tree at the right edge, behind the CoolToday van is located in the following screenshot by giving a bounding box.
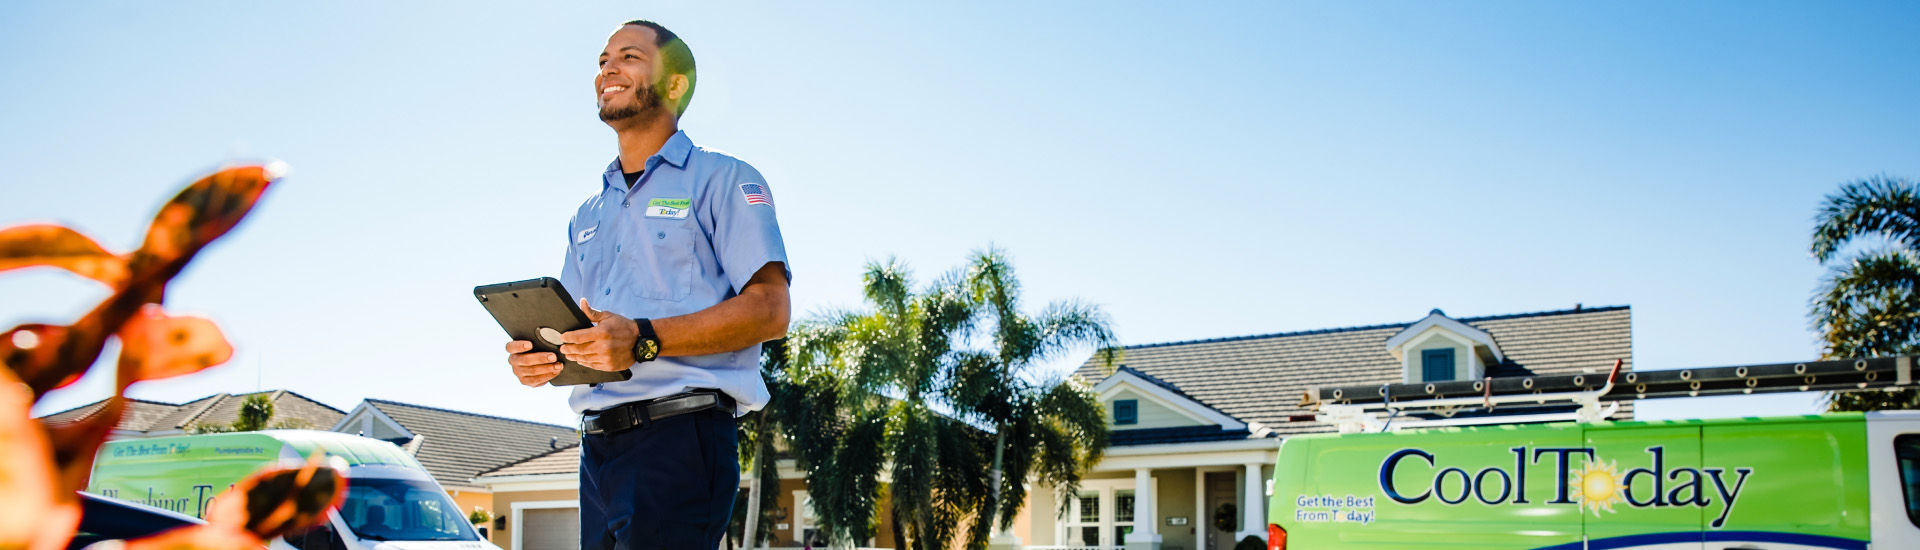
[1811,177,1920,410]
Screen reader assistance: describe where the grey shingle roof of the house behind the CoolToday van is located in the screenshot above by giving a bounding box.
[1073,306,1634,435]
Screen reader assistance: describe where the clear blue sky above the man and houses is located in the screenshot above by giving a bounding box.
[0,2,1920,423]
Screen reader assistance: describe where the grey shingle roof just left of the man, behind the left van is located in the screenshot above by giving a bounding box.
[367,400,580,488]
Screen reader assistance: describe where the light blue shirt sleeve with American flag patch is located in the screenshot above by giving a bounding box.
[705,162,793,294]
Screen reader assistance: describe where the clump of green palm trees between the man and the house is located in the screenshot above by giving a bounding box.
[787,250,1112,548]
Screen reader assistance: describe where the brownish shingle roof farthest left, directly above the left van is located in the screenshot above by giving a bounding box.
[46,390,348,433]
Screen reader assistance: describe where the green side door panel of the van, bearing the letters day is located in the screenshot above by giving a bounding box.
[1565,423,1713,550]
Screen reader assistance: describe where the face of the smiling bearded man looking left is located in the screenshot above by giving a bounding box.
[593,25,666,123]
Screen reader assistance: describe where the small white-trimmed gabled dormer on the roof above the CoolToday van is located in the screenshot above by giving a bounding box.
[1386,310,1505,383]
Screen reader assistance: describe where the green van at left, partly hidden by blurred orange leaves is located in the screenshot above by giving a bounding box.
[86,431,499,550]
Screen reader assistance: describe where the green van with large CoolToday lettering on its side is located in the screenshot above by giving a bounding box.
[1267,412,1920,550]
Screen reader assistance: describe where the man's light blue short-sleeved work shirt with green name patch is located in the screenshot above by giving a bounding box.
[561,133,793,415]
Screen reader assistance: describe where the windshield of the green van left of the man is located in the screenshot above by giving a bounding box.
[340,477,480,540]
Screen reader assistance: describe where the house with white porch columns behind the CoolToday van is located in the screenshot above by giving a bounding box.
[1010,306,1632,550]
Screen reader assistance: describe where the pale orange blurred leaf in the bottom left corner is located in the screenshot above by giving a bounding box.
[0,369,81,550]
